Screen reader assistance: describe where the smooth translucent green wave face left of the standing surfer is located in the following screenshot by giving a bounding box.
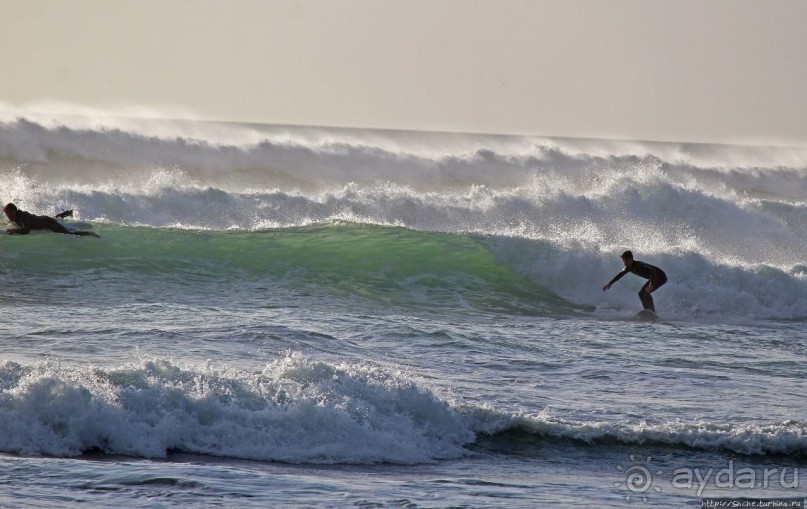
[3,222,573,315]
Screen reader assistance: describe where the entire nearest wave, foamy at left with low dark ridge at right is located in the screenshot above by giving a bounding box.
[0,354,807,464]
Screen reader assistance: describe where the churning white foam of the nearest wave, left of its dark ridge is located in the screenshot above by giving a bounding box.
[0,356,474,464]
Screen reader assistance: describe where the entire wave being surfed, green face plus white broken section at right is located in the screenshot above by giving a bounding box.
[3,221,807,321]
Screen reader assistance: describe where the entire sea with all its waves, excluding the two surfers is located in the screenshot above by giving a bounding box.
[0,115,807,508]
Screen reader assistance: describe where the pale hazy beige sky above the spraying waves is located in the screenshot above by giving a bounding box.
[0,0,807,145]
